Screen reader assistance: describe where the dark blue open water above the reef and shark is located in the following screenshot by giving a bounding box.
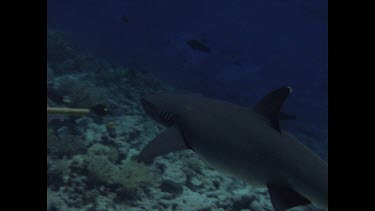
[48,0,328,157]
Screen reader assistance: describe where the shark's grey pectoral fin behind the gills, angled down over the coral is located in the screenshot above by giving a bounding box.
[137,126,187,163]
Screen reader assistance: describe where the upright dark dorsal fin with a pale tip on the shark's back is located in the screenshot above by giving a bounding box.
[254,86,292,132]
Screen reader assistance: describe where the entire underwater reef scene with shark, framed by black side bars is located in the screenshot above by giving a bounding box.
[47,0,328,211]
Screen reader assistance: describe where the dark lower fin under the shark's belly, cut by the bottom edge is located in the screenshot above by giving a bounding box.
[267,184,311,211]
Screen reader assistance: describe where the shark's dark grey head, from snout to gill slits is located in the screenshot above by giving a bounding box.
[141,94,178,127]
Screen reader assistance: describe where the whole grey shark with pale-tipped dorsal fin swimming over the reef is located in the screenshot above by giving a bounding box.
[138,87,328,211]
